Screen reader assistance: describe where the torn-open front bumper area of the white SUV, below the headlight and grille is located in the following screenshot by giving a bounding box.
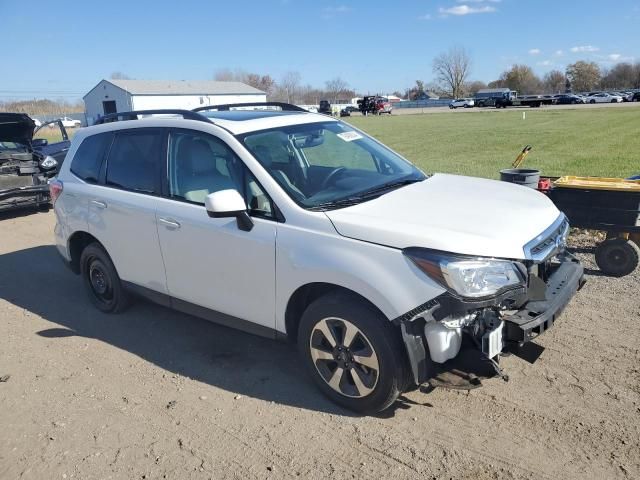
[395,253,584,388]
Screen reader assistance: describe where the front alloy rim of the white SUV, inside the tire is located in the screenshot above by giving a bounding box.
[309,318,380,398]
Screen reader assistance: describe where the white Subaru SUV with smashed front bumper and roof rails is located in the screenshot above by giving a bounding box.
[50,103,583,412]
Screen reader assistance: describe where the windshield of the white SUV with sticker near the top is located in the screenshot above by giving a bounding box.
[240,122,426,209]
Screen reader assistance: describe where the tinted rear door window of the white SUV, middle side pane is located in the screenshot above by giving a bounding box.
[105,129,162,194]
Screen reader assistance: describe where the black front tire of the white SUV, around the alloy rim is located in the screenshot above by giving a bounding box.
[298,294,408,414]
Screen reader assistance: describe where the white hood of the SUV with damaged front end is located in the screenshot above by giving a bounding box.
[326,174,560,259]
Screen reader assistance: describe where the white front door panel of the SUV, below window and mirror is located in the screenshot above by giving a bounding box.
[156,198,277,329]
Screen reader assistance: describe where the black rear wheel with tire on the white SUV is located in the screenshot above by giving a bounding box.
[80,242,129,313]
